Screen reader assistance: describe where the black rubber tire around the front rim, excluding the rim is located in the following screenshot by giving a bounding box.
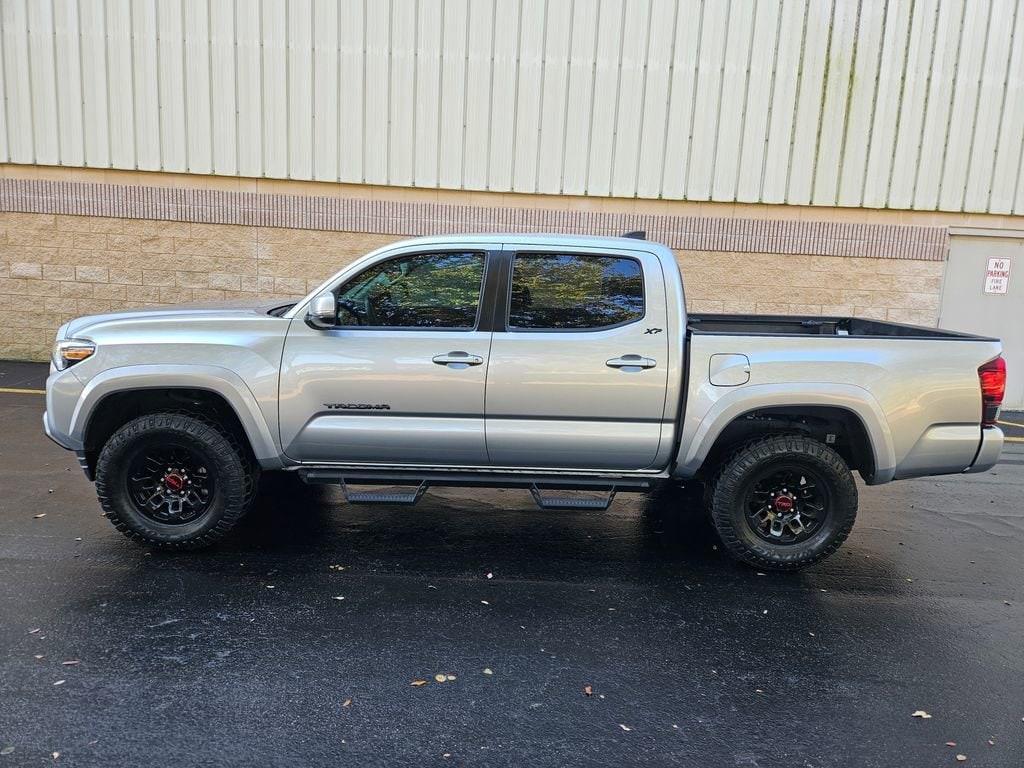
[96,413,256,550]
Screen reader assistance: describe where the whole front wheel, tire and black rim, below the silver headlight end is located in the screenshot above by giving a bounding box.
[96,413,255,549]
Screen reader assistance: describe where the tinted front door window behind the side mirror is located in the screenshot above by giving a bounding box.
[338,253,484,329]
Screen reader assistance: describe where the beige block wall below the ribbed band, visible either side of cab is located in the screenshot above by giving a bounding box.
[0,213,944,359]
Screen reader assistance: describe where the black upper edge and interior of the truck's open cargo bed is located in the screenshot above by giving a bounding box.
[686,313,991,341]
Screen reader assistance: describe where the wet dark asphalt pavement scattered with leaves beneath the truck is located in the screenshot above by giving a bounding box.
[0,365,1024,768]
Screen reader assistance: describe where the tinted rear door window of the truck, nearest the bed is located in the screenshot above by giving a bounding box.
[509,254,644,329]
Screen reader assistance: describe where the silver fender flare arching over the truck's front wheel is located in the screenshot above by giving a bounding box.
[69,365,282,469]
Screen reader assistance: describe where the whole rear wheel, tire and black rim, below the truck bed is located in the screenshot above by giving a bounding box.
[710,435,857,570]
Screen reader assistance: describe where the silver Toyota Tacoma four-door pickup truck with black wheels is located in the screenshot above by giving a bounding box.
[43,234,1006,569]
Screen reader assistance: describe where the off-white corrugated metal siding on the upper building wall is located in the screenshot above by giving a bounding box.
[0,0,1024,213]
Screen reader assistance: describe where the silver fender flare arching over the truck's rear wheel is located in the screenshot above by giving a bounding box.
[674,382,896,484]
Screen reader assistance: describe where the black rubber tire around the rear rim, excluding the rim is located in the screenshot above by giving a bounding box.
[710,435,857,570]
